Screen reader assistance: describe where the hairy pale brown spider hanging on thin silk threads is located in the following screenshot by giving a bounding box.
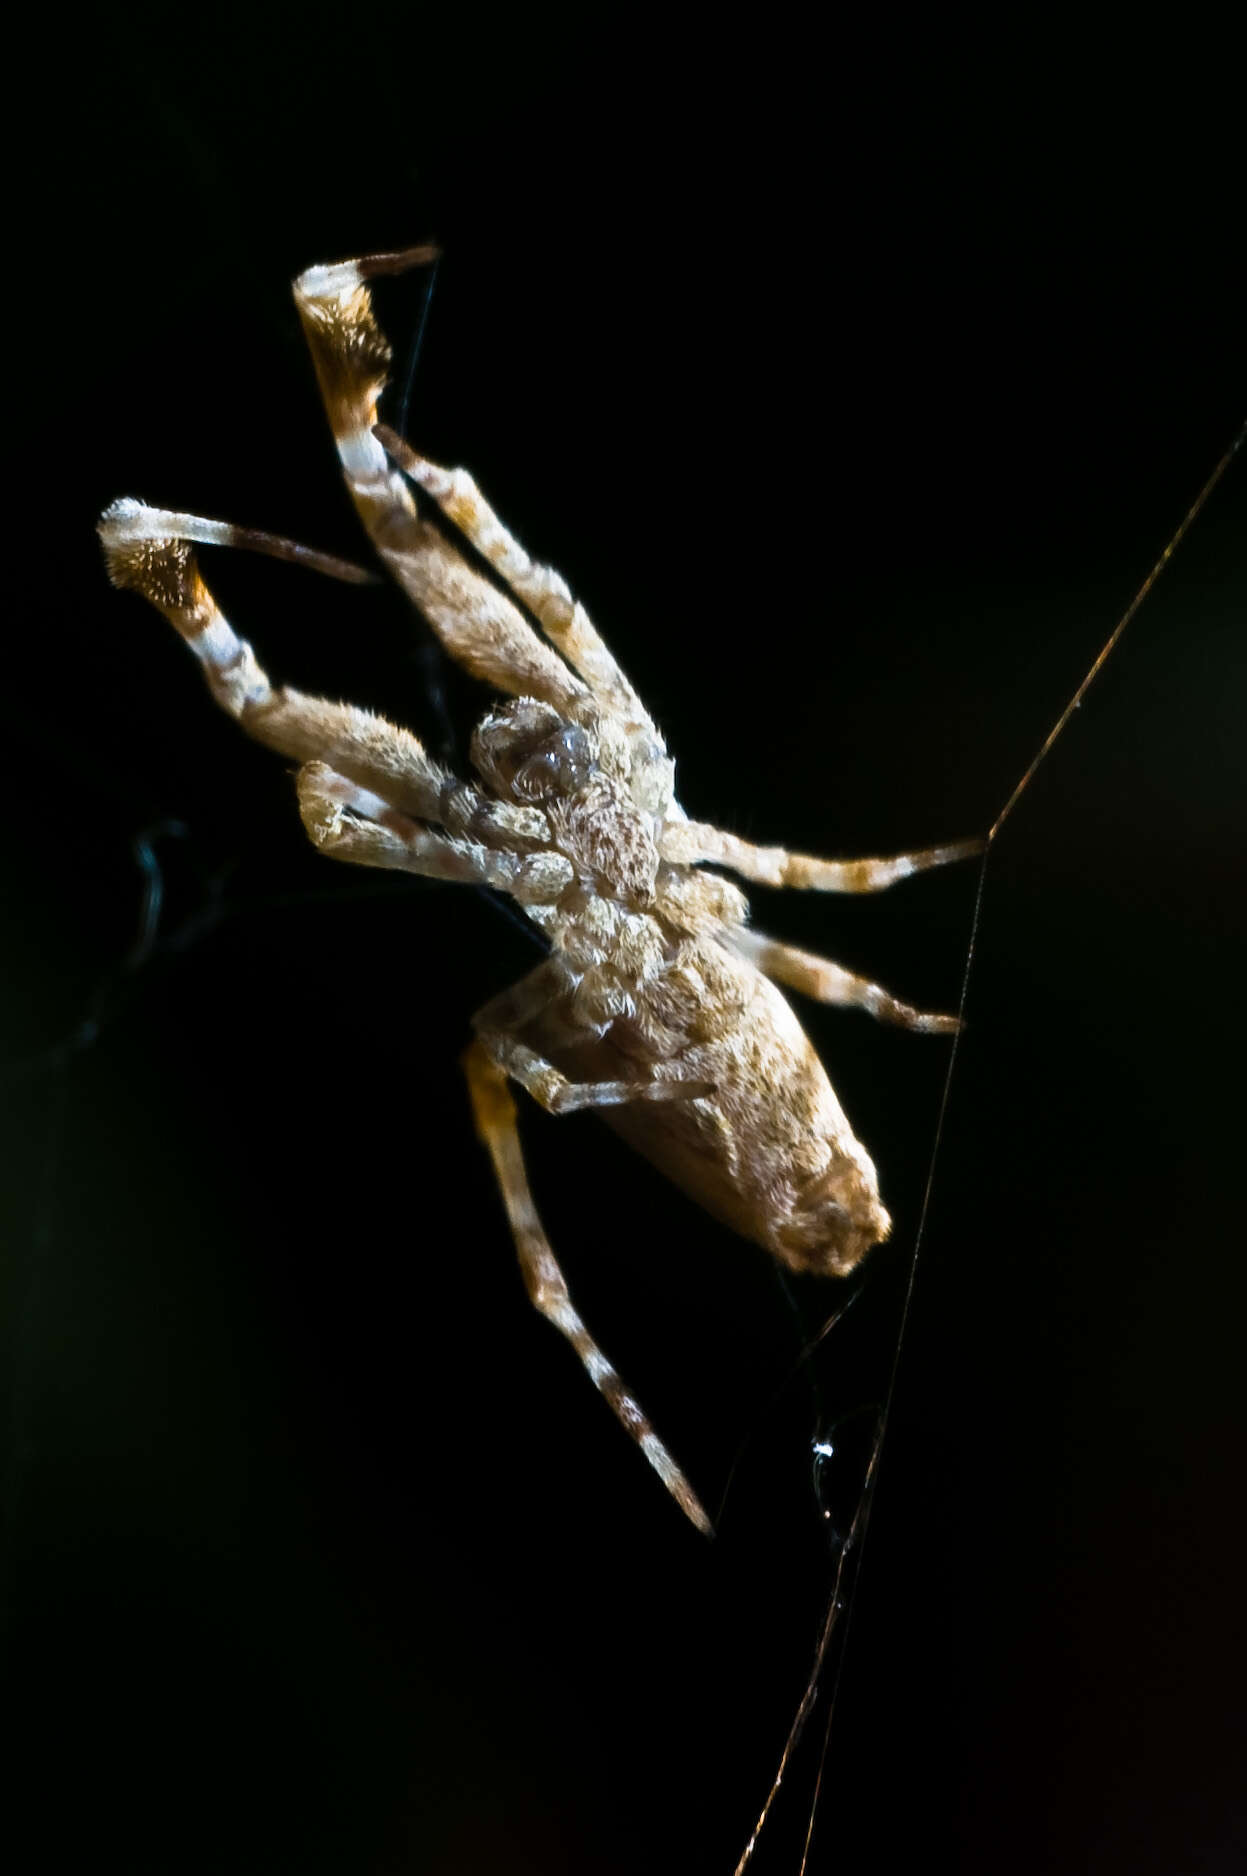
[99,248,981,1535]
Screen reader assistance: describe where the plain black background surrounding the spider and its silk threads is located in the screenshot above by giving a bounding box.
[4,8,1247,1876]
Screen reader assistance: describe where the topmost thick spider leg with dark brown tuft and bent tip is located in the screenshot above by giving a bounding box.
[294,248,589,717]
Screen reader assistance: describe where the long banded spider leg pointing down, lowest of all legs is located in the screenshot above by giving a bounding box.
[463,1041,713,1536]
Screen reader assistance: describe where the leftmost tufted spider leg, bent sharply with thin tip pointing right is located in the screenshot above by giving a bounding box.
[99,499,549,848]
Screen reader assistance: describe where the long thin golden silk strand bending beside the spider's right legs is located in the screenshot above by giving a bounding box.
[735,422,1247,1876]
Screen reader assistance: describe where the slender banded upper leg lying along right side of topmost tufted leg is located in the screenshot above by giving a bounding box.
[375,424,656,735]
